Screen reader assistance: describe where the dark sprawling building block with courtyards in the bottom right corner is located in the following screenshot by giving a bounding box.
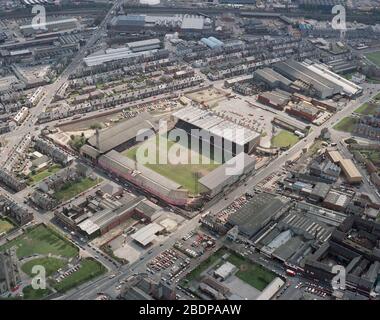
[304,216,380,296]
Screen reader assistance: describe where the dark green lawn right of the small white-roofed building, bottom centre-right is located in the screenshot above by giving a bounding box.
[227,253,276,291]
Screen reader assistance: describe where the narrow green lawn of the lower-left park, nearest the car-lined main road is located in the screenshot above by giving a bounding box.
[53,258,107,292]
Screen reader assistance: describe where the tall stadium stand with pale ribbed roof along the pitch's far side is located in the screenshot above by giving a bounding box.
[172,106,260,160]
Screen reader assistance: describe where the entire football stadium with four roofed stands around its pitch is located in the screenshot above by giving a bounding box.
[81,107,260,207]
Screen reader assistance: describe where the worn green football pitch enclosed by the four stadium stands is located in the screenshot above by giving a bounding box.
[122,136,220,194]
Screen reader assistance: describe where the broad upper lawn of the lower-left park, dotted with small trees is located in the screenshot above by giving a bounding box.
[0,224,78,258]
